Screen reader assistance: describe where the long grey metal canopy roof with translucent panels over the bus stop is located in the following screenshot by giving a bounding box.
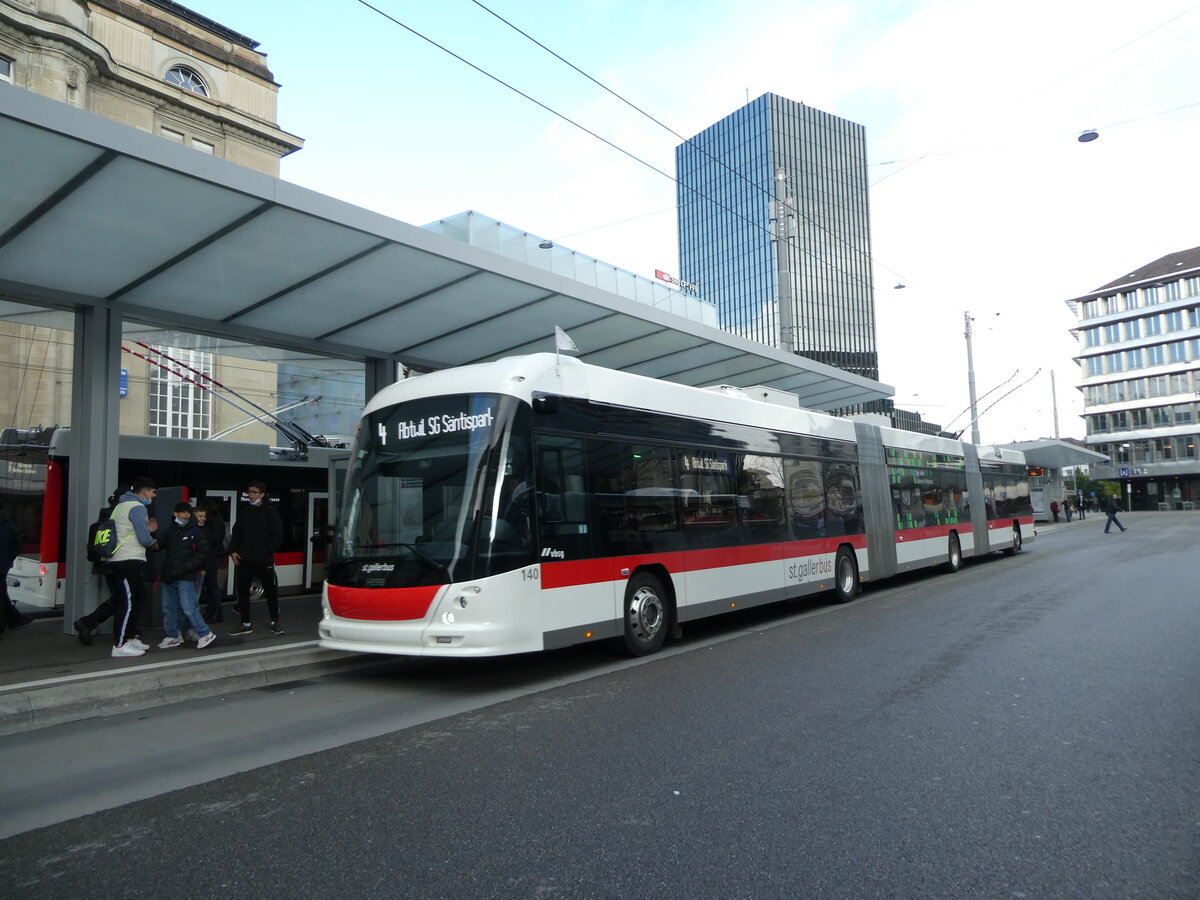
[0,84,893,409]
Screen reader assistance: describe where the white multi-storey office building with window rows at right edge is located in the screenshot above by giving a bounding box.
[1067,247,1200,509]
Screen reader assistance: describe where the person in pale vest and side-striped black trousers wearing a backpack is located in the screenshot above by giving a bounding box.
[90,476,158,656]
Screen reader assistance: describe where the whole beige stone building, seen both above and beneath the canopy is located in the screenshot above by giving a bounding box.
[0,0,302,443]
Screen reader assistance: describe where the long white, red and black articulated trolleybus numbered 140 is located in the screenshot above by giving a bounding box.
[319,354,1033,656]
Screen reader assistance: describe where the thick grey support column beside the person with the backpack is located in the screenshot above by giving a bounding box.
[61,307,121,634]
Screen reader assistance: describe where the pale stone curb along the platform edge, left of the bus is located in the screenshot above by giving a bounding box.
[0,641,379,736]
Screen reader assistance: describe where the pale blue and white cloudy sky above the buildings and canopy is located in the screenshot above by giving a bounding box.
[185,0,1200,443]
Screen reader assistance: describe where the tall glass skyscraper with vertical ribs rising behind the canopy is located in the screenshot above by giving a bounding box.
[676,94,878,379]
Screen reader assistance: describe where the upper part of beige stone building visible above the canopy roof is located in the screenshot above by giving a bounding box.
[0,0,304,175]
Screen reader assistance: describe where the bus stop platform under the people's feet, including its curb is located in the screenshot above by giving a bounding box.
[0,594,382,736]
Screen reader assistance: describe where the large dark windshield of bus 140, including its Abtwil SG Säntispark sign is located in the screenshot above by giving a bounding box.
[326,394,534,588]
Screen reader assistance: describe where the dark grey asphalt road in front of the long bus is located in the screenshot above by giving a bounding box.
[0,514,1200,900]
